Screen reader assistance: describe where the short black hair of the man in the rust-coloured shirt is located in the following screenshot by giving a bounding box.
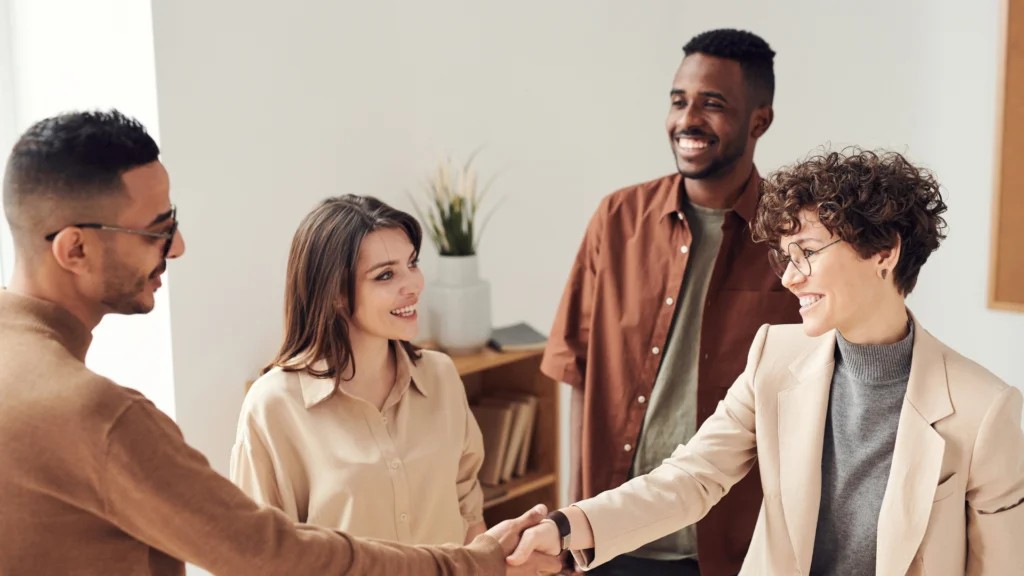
[683,29,775,106]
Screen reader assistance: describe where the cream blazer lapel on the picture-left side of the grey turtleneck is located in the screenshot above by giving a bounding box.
[778,332,836,574]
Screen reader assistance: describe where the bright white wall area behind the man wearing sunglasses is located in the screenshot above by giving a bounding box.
[0,0,174,417]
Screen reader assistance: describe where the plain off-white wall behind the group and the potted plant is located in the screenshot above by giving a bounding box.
[154,0,1024,516]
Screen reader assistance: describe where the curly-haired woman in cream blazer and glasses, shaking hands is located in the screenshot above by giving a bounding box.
[509,149,1024,576]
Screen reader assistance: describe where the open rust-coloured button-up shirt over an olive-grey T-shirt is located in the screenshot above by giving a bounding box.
[541,169,800,576]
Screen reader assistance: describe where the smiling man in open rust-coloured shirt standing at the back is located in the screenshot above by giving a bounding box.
[542,30,800,576]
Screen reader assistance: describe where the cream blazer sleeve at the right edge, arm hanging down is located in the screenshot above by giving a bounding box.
[967,386,1024,576]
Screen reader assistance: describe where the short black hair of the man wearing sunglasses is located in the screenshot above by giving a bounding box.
[3,110,160,213]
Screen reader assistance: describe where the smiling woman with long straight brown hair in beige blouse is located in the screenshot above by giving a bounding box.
[230,195,484,544]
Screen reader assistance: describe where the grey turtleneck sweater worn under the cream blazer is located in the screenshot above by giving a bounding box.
[811,323,913,576]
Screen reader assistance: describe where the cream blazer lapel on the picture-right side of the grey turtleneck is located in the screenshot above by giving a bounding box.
[876,316,953,576]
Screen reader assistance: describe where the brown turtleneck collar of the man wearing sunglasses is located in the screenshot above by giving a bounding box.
[0,288,92,362]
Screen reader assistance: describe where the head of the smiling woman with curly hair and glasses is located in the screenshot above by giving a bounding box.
[753,148,946,343]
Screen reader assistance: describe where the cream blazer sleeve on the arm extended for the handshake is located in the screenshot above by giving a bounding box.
[573,325,768,569]
